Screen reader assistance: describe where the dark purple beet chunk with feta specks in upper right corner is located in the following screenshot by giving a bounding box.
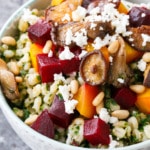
[129,7,150,27]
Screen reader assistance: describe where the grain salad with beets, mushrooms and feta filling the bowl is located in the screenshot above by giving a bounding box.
[0,0,150,148]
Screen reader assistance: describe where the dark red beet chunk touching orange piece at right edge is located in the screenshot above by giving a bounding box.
[114,87,137,109]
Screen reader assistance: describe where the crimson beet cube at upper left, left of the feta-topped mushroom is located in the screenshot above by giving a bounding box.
[28,20,52,45]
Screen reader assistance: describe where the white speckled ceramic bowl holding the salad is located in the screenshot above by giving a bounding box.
[0,0,150,150]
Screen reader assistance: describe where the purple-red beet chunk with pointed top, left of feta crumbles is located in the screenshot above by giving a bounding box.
[49,96,74,128]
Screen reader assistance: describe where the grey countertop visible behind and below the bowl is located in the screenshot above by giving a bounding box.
[0,0,30,150]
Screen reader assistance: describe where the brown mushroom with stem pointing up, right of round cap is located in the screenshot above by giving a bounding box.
[108,37,133,88]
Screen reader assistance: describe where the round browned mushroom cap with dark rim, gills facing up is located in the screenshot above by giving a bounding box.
[80,50,108,85]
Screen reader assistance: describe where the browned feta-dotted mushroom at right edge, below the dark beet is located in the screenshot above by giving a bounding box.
[126,25,150,51]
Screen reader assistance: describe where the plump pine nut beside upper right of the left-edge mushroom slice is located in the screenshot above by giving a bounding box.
[7,61,20,75]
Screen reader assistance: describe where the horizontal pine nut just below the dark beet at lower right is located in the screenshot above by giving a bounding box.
[111,110,129,119]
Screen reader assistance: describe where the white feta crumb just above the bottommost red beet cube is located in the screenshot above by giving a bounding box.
[99,108,110,123]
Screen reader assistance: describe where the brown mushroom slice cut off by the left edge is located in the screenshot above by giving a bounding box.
[0,59,19,102]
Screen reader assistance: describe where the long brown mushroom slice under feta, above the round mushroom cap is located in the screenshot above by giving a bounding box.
[52,22,114,46]
